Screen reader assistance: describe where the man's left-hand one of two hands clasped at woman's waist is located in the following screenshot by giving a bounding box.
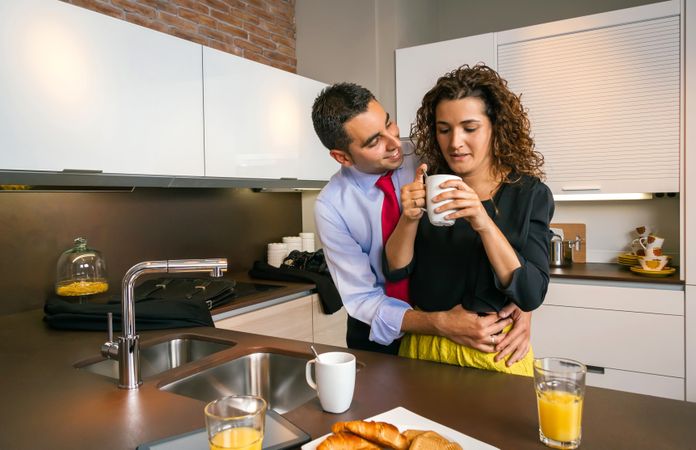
[436,305,513,353]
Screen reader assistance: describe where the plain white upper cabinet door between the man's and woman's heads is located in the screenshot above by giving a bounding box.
[396,33,496,137]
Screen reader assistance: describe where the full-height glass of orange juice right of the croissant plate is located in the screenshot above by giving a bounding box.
[534,358,587,449]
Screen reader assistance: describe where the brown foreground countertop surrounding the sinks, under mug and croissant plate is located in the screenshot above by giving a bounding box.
[0,304,696,450]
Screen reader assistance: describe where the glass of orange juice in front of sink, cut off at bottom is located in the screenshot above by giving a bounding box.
[205,395,267,450]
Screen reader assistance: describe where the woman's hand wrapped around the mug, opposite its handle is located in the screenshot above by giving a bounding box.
[433,180,493,233]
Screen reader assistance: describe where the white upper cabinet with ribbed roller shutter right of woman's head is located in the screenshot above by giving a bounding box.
[497,1,681,194]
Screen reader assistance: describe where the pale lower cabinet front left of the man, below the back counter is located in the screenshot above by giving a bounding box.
[215,294,346,347]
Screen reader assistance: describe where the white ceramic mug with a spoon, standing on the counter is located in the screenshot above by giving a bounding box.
[305,352,355,413]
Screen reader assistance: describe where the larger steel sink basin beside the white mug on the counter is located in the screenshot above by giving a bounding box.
[160,352,316,414]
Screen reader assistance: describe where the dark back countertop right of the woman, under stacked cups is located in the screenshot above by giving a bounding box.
[549,263,684,286]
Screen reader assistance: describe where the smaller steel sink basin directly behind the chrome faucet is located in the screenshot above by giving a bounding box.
[76,336,234,379]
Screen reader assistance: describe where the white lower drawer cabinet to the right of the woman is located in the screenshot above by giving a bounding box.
[532,282,685,400]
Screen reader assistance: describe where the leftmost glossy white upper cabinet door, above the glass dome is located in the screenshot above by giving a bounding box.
[0,0,203,176]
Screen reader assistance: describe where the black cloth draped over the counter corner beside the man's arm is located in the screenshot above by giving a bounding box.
[249,261,343,314]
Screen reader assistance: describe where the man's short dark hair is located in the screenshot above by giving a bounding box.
[312,83,375,152]
